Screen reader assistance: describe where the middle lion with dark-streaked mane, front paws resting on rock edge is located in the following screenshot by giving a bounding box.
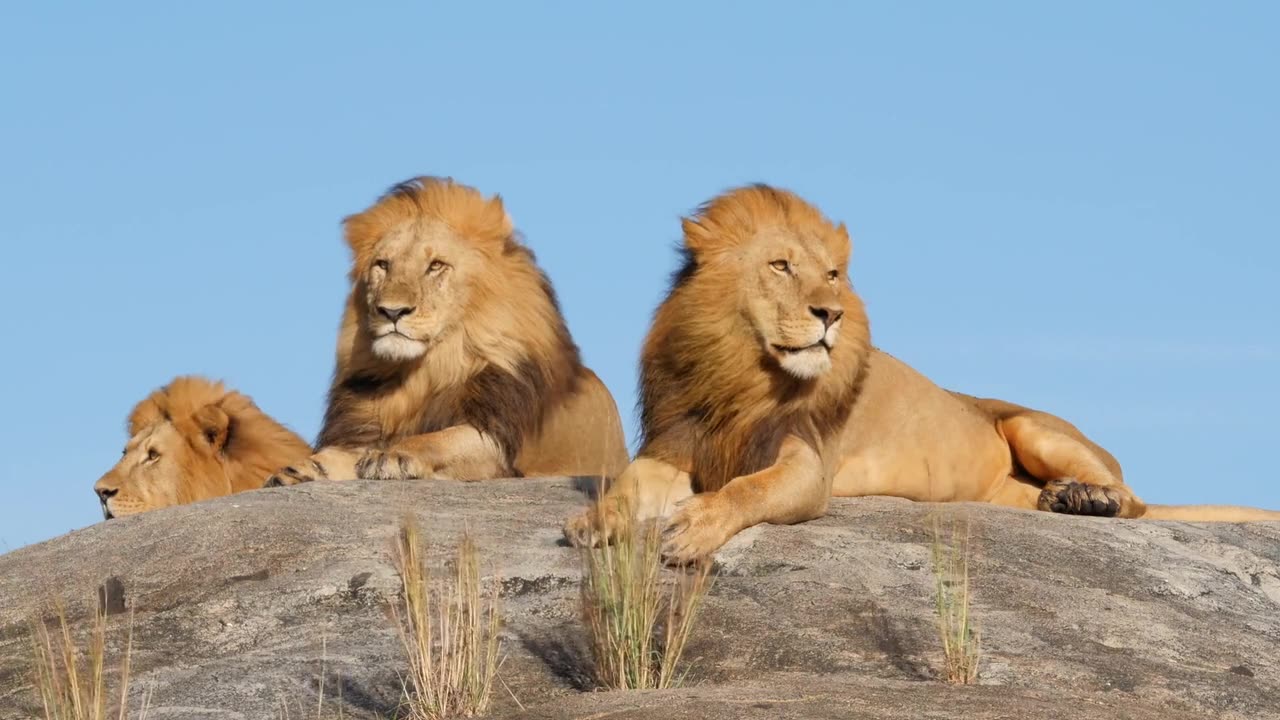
[268,177,627,487]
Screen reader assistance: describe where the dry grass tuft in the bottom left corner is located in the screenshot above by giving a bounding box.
[31,603,150,720]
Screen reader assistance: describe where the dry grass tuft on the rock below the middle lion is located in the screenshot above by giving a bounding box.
[393,518,500,720]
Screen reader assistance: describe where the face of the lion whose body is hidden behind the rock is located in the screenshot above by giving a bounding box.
[93,421,230,520]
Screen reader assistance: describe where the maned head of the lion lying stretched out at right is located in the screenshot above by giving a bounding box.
[640,184,870,489]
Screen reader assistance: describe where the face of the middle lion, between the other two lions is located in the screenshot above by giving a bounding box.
[361,219,479,361]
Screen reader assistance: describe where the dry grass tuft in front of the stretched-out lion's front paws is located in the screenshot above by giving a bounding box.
[581,499,712,689]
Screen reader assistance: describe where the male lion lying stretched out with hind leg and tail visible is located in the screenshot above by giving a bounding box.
[564,184,1280,562]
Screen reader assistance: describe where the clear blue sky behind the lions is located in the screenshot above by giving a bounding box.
[0,1,1280,550]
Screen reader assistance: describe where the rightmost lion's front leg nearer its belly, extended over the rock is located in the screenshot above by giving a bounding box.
[662,436,831,564]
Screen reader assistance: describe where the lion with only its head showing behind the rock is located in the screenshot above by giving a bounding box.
[93,375,311,520]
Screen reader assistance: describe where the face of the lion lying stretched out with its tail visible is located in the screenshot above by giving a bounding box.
[735,228,845,379]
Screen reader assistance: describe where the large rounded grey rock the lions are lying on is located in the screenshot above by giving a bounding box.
[0,479,1280,720]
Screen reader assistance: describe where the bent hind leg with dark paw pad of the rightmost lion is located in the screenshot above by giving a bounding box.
[1000,411,1146,518]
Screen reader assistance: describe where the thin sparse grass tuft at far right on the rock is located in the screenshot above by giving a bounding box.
[932,507,982,685]
